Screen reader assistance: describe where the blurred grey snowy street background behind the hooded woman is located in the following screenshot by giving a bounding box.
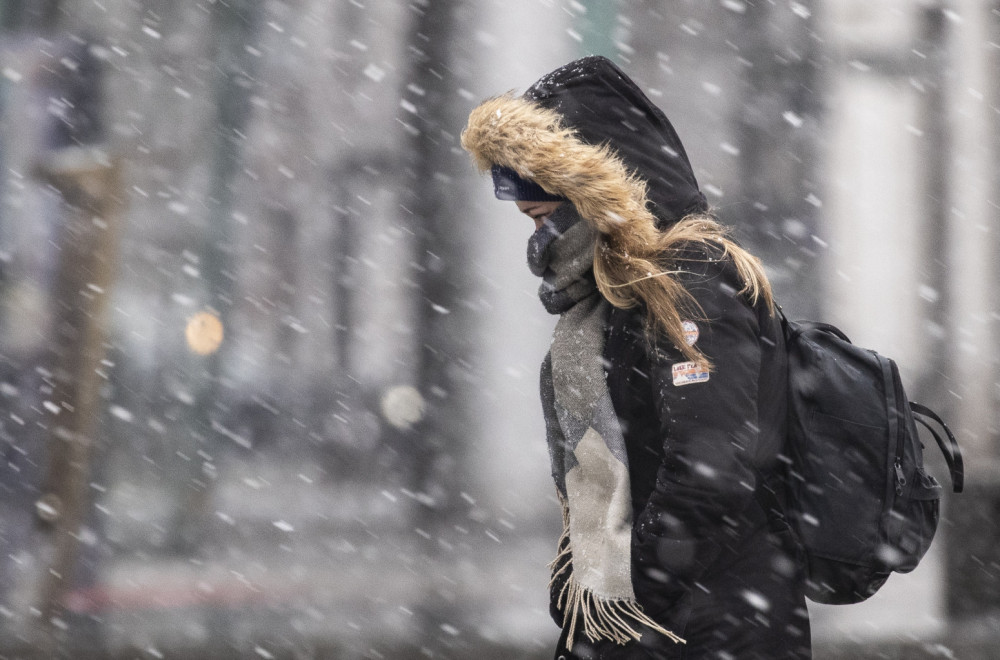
[0,0,1000,659]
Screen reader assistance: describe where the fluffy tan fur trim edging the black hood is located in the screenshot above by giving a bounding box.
[462,94,655,234]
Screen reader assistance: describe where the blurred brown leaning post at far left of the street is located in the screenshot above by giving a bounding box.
[36,147,124,653]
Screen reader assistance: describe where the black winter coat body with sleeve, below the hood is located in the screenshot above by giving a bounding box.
[552,249,810,660]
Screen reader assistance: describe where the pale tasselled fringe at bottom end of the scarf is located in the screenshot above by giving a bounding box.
[549,508,686,651]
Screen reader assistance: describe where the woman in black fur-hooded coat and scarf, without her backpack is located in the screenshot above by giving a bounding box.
[462,57,810,660]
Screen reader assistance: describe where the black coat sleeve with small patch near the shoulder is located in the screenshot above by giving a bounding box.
[633,255,761,591]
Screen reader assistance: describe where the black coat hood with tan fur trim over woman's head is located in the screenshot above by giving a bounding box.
[462,56,708,234]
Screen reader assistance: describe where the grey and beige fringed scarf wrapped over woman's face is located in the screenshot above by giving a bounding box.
[528,203,683,648]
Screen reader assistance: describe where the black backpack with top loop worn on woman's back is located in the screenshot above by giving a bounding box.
[757,313,964,604]
